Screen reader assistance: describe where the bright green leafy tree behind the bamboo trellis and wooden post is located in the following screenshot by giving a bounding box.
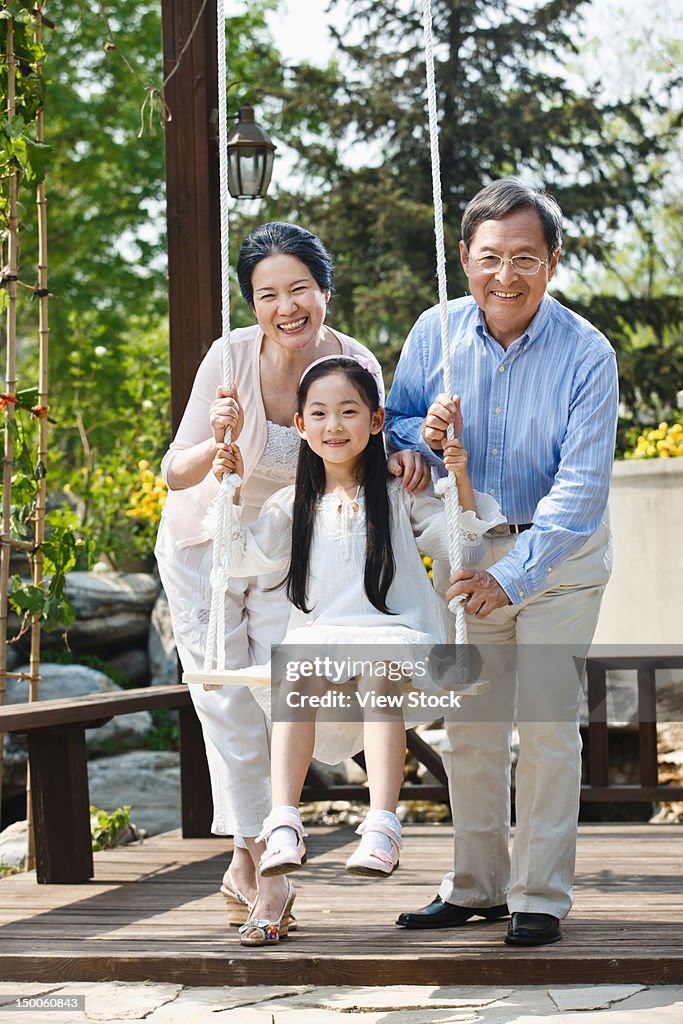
[5,0,288,561]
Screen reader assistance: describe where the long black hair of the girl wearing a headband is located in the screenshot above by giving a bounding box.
[284,355,395,614]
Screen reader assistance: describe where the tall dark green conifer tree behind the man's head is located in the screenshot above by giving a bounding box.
[242,0,674,387]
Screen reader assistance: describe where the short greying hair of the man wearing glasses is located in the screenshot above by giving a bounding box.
[461,178,562,253]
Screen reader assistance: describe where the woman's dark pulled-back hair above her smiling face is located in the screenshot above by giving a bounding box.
[238,220,334,309]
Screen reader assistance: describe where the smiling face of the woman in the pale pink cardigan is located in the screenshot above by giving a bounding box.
[252,254,330,350]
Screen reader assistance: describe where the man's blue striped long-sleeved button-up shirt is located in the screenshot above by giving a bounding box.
[387,295,618,604]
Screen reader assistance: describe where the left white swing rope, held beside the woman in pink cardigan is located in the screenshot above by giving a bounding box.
[204,0,242,675]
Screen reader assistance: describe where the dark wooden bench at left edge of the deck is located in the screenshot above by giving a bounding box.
[0,685,212,883]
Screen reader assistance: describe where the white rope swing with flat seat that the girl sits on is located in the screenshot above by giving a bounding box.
[182,0,471,692]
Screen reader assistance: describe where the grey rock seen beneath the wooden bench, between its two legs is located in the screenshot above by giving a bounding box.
[88,751,180,836]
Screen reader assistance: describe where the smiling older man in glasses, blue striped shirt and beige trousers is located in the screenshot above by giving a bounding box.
[387,178,617,946]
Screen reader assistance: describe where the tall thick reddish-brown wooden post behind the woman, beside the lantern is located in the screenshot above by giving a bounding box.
[162,0,221,432]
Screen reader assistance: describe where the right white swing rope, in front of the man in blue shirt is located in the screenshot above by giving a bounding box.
[422,0,467,647]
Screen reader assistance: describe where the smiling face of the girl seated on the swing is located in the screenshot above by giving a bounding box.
[294,371,384,470]
